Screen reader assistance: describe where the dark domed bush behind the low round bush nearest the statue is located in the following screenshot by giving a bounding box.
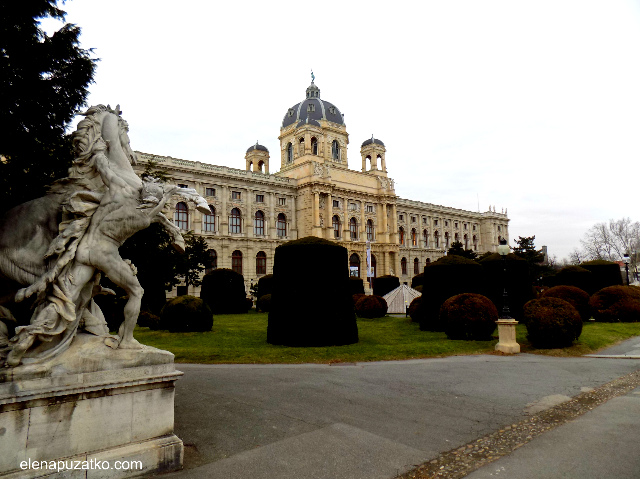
[200,268,249,314]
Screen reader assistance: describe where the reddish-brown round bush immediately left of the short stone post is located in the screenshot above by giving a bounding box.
[440,293,498,341]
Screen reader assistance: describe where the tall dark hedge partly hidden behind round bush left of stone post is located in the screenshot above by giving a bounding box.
[418,256,484,331]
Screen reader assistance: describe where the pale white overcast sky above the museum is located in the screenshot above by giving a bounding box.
[45,0,640,259]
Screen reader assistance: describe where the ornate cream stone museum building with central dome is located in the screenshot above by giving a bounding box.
[137,82,509,294]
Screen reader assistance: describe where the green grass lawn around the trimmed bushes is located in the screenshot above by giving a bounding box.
[134,312,640,364]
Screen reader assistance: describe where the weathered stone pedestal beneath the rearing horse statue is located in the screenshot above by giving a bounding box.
[0,334,183,479]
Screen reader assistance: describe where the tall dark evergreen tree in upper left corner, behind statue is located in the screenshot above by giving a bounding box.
[0,0,98,212]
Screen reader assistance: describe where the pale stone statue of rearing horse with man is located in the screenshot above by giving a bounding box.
[0,105,210,367]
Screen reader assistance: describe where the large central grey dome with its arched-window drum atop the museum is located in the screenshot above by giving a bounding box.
[278,81,349,173]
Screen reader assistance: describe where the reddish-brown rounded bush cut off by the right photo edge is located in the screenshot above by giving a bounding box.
[589,286,640,323]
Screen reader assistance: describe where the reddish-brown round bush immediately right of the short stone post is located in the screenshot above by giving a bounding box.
[524,297,582,348]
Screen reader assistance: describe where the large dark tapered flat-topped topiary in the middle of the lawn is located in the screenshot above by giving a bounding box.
[267,236,358,346]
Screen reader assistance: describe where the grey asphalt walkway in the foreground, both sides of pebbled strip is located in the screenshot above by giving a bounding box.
[164,338,640,479]
